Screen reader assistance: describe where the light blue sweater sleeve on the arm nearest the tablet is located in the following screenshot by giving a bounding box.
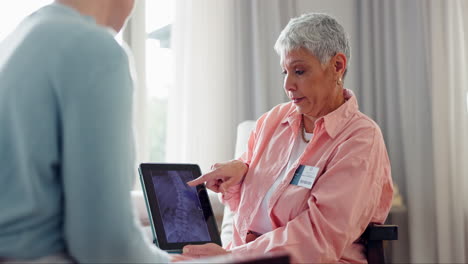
[56,32,169,263]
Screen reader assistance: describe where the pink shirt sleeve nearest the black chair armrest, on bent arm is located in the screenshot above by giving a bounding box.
[232,125,393,263]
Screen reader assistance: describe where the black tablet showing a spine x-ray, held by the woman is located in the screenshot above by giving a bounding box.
[138,163,221,253]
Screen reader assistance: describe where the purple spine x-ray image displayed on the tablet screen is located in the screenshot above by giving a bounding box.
[151,171,211,243]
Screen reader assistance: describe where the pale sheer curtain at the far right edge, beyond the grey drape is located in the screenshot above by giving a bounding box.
[429,0,468,263]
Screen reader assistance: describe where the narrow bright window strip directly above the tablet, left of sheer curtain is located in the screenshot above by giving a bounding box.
[145,0,175,162]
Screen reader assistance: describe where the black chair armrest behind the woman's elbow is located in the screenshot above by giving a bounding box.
[361,223,398,264]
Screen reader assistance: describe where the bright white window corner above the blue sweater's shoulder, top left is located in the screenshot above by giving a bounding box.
[0,0,52,41]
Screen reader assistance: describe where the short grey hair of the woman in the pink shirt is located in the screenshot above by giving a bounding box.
[275,13,351,71]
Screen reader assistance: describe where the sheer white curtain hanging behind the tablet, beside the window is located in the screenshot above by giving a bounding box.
[166,0,236,171]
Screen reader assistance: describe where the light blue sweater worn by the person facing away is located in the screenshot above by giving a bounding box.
[0,4,168,263]
